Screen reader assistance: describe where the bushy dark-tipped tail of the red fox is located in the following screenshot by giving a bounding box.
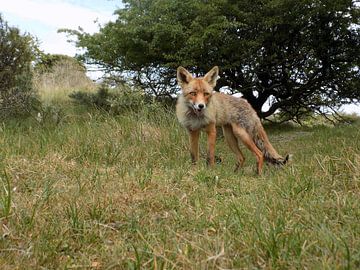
[253,126,291,165]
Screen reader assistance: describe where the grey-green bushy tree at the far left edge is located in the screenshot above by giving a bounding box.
[0,14,35,118]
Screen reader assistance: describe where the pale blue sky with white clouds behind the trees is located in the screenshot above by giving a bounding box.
[0,0,360,115]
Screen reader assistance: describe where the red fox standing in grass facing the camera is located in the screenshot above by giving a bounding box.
[176,66,290,175]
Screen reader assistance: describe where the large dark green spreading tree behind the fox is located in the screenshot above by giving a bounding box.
[65,0,360,118]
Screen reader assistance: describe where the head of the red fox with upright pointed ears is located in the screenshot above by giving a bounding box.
[177,66,219,114]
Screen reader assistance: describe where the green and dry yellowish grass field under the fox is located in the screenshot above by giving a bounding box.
[0,102,360,269]
